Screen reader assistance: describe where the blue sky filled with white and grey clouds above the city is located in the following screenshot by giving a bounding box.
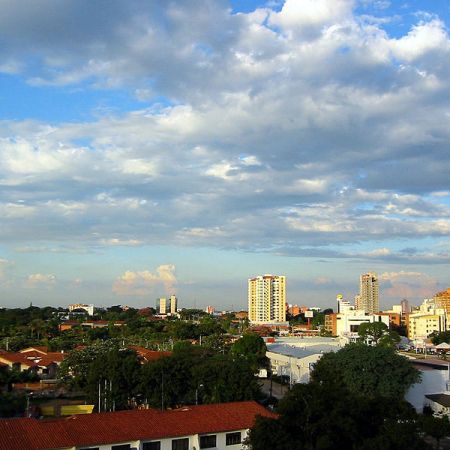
[0,0,450,309]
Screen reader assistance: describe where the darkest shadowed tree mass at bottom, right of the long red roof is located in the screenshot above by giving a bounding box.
[248,383,428,450]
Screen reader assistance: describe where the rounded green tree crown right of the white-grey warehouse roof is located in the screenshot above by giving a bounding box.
[312,344,420,398]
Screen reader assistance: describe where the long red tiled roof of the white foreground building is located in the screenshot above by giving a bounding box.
[0,401,277,450]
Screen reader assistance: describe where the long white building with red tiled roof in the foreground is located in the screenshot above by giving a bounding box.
[0,401,276,450]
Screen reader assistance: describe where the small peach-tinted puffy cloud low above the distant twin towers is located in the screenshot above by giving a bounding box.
[112,264,177,297]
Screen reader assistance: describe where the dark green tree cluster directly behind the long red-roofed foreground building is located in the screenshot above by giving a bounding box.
[59,334,265,410]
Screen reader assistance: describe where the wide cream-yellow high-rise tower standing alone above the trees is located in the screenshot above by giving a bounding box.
[248,275,286,323]
